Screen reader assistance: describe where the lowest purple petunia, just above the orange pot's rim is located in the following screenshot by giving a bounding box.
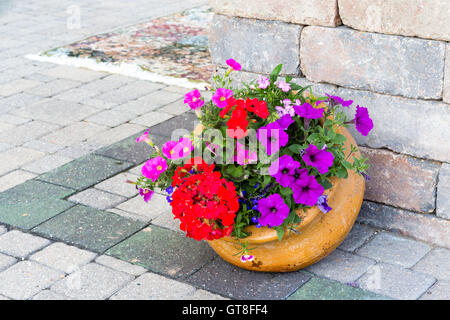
[258,193,290,227]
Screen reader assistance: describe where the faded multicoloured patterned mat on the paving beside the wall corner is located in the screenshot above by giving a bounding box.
[30,6,214,84]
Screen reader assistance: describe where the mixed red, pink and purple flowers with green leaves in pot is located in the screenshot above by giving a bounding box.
[135,59,373,262]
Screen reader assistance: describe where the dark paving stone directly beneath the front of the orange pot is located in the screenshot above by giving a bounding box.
[187,257,311,300]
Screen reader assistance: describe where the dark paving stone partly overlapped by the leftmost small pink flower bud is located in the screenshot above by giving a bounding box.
[95,133,167,164]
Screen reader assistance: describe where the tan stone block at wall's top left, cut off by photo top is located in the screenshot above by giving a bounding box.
[209,0,341,27]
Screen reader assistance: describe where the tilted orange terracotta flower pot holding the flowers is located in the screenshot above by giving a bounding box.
[208,128,364,272]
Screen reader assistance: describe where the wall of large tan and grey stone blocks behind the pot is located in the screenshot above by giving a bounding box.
[210,0,450,246]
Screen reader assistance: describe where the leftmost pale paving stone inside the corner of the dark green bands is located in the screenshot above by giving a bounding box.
[68,188,126,210]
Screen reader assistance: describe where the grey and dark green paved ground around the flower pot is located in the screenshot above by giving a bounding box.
[0,0,450,299]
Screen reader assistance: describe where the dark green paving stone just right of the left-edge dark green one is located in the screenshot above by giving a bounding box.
[32,205,145,252]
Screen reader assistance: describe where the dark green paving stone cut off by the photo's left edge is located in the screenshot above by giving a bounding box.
[0,199,73,230]
